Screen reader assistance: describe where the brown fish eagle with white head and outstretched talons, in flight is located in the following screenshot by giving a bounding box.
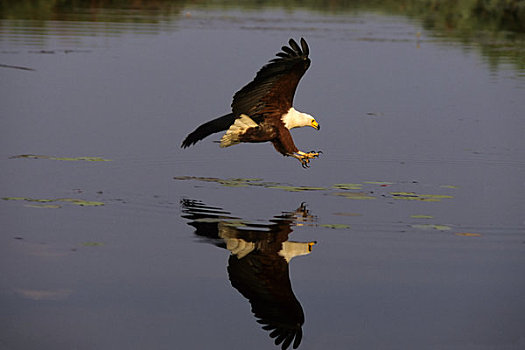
[181,38,320,167]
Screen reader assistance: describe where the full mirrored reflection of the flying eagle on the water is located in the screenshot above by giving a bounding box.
[182,200,315,349]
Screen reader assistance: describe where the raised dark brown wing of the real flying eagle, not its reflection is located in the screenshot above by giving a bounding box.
[232,38,310,121]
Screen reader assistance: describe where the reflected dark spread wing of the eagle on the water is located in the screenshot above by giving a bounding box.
[228,252,304,349]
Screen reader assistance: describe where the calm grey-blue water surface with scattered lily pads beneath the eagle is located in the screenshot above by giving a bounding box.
[0,7,525,349]
